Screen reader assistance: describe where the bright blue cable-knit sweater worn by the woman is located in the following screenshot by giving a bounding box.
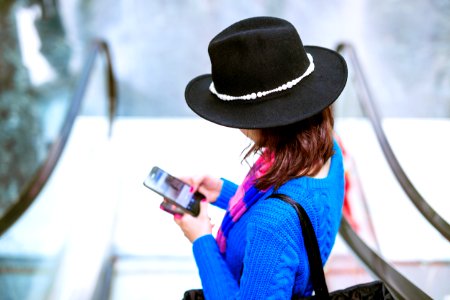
[193,143,344,300]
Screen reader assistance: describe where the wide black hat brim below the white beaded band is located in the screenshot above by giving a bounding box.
[185,46,348,129]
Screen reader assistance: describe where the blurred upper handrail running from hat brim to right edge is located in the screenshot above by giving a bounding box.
[337,43,450,241]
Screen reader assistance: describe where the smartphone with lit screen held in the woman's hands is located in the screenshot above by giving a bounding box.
[144,167,205,217]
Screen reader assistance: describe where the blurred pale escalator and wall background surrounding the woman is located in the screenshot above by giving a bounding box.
[0,0,450,299]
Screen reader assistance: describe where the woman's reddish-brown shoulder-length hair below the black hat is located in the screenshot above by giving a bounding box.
[244,107,334,190]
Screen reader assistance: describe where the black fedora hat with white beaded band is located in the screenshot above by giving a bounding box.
[185,17,347,129]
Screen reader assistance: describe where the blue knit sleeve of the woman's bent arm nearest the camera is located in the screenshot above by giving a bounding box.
[193,203,300,300]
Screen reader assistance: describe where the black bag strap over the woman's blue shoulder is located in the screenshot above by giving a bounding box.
[268,193,329,299]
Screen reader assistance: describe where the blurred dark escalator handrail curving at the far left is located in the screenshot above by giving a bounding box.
[0,41,117,236]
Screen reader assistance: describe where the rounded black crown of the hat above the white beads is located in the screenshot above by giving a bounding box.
[208,17,310,96]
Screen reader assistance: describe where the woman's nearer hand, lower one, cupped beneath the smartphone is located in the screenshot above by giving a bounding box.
[174,201,214,243]
